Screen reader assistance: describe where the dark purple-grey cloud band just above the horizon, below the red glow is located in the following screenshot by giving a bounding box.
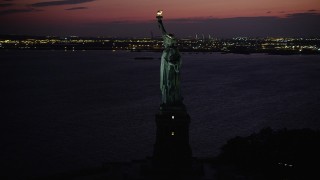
[0,10,320,38]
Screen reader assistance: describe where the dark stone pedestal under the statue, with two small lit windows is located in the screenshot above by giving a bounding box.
[153,104,192,170]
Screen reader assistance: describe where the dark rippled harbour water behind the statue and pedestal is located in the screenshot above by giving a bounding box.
[0,51,320,177]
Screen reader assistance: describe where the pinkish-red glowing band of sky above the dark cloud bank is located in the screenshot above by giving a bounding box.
[0,0,320,23]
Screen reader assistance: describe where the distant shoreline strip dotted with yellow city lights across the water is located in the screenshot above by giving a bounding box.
[0,36,320,54]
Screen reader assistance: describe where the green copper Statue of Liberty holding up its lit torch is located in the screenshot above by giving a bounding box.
[157,11,182,106]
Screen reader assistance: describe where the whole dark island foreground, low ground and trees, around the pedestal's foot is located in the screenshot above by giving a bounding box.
[30,128,320,180]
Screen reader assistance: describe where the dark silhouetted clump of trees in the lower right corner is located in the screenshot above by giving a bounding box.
[216,128,320,180]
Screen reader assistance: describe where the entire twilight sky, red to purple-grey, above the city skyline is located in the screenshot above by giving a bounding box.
[0,0,320,37]
